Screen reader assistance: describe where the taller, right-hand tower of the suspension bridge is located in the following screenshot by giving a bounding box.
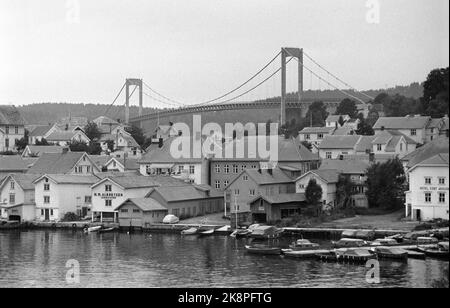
[280,47,303,126]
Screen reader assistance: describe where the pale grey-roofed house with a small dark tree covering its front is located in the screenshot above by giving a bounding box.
[295,169,339,210]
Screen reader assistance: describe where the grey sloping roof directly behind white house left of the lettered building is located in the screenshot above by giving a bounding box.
[28,152,86,174]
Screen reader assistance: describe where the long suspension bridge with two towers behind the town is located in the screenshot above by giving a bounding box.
[105,48,373,133]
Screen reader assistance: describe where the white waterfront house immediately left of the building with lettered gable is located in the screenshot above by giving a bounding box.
[33,174,98,221]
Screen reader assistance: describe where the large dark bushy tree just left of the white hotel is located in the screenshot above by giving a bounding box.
[366,158,406,210]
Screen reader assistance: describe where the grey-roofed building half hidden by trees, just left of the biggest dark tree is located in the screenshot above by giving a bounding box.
[319,159,371,208]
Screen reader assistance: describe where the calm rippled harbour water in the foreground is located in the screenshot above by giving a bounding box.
[0,231,448,287]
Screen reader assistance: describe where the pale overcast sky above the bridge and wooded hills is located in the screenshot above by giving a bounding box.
[0,0,449,107]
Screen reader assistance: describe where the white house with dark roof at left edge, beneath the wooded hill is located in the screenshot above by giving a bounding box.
[0,106,25,152]
